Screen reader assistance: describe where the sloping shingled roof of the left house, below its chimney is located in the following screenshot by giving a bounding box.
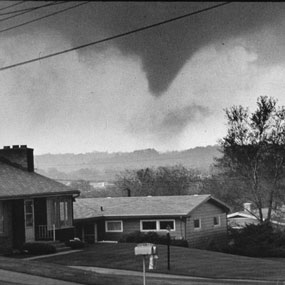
[0,160,80,200]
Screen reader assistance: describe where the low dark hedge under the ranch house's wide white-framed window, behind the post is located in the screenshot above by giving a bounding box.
[119,231,188,247]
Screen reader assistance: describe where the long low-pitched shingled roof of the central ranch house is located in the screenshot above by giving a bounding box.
[74,195,229,220]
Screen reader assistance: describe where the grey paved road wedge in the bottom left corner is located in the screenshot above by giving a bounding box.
[0,269,79,285]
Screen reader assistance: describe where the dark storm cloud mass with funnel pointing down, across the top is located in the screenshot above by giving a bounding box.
[20,2,285,96]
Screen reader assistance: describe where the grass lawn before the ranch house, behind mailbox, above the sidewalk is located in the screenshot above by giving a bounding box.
[39,243,285,280]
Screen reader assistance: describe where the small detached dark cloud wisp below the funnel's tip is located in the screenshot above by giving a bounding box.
[159,104,211,134]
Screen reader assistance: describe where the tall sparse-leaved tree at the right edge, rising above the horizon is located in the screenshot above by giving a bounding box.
[217,96,285,221]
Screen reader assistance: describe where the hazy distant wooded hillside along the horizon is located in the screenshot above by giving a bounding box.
[35,143,220,181]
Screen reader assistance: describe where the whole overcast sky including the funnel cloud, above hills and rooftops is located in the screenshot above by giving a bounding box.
[0,1,285,154]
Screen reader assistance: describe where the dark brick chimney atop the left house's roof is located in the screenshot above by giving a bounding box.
[0,145,34,172]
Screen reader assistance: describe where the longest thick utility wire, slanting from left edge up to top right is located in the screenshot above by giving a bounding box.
[0,2,231,71]
